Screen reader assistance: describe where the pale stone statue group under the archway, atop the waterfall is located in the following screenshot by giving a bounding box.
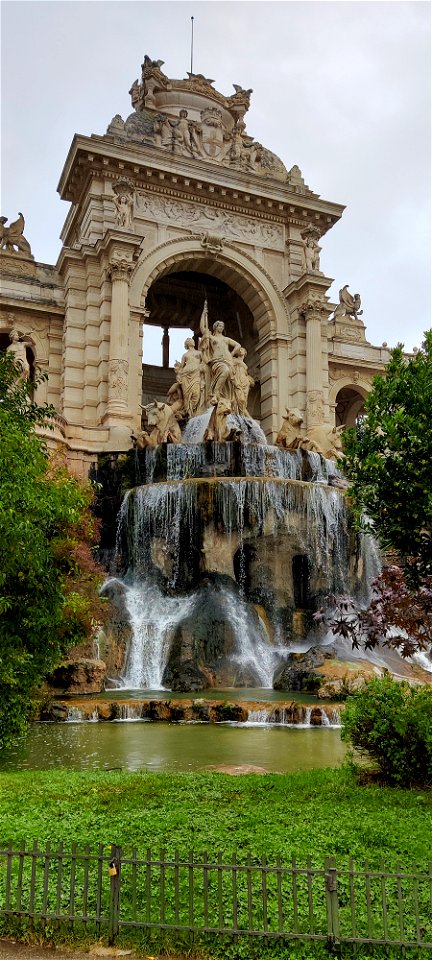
[135,302,255,449]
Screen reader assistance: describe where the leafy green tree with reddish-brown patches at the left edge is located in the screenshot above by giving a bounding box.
[0,353,106,746]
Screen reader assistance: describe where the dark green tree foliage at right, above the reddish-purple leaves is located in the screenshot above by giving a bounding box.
[343,330,432,586]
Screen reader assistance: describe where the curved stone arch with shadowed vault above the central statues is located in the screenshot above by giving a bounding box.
[130,236,289,434]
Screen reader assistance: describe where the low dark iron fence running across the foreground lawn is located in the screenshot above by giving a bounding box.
[0,843,432,950]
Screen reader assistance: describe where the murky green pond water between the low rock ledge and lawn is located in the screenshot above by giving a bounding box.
[0,721,346,773]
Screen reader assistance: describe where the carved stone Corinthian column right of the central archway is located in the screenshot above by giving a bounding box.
[300,297,327,430]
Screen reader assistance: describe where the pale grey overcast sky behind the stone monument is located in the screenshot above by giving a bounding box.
[1,0,431,364]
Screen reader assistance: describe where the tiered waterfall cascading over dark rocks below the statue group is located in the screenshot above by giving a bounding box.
[104,410,362,690]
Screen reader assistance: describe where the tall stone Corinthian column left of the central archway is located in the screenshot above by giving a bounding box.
[107,254,134,417]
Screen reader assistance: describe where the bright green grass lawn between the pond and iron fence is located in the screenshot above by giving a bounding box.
[0,768,432,960]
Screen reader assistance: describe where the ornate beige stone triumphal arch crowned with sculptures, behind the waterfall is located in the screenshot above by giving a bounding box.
[0,56,389,475]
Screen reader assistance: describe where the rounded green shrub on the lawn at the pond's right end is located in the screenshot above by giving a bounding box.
[342,675,432,787]
